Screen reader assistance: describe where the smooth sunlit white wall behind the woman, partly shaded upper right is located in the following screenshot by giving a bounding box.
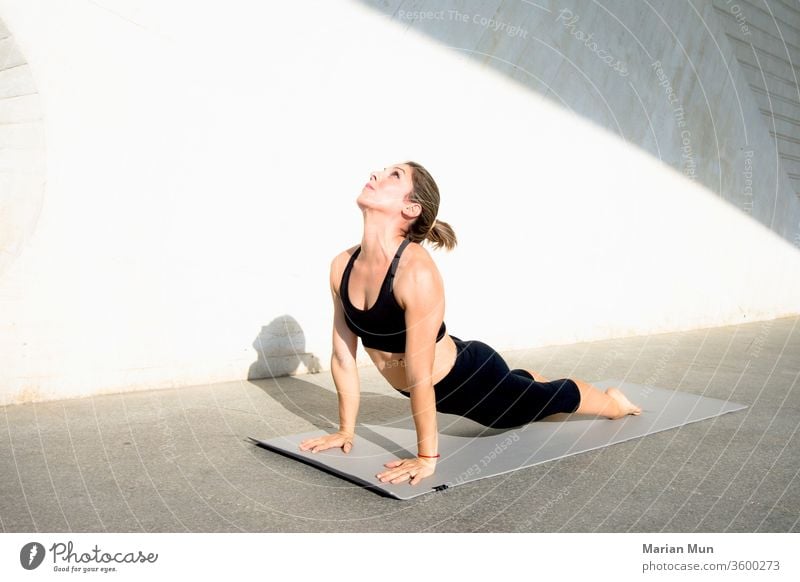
[0,0,800,404]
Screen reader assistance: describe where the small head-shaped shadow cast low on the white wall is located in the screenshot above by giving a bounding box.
[247,315,322,380]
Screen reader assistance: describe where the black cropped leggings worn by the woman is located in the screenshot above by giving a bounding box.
[406,335,581,428]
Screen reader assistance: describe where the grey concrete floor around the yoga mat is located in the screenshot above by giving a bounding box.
[0,317,800,532]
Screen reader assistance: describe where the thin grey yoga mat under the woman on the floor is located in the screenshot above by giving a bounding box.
[250,380,747,499]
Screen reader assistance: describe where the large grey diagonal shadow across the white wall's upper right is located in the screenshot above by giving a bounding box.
[359,0,800,246]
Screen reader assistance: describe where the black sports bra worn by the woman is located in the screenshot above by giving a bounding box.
[339,237,447,353]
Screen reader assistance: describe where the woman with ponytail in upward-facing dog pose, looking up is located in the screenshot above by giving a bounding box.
[300,161,641,485]
